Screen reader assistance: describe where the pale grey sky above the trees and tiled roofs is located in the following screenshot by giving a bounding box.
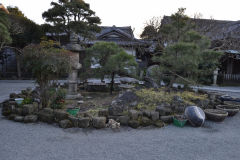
[0,0,240,37]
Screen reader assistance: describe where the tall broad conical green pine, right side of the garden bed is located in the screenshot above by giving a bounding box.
[154,9,222,85]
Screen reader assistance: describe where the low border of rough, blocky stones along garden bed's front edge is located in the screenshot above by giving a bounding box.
[2,90,225,129]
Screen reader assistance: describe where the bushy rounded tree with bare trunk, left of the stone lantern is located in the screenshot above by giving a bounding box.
[23,42,72,107]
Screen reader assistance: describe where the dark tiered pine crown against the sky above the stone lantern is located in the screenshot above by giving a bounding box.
[42,0,101,41]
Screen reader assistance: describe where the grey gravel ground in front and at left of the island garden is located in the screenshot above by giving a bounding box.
[0,82,240,160]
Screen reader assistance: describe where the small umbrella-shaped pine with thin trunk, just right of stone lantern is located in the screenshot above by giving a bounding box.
[85,42,137,94]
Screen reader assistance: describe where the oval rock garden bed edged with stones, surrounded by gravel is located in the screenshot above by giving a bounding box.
[2,86,239,129]
